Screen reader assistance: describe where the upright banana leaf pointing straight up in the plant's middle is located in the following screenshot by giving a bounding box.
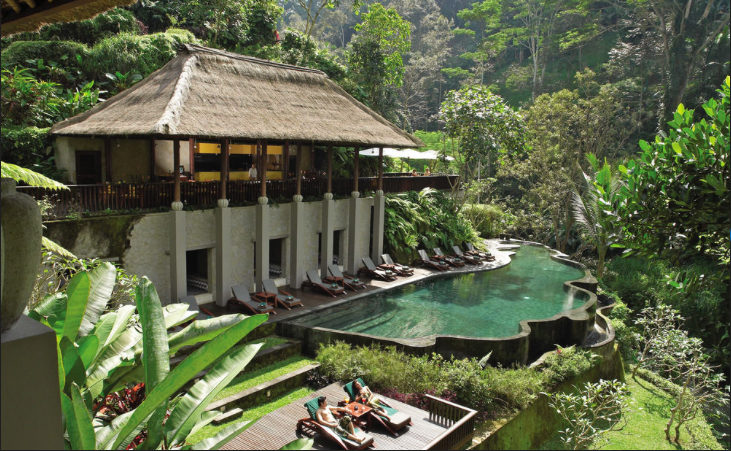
[135,277,170,449]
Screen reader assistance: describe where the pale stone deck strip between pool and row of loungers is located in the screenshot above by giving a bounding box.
[201,239,520,323]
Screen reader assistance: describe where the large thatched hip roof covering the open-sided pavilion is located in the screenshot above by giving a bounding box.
[51,45,424,147]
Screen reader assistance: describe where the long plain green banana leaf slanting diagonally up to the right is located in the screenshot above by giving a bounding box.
[113,315,268,448]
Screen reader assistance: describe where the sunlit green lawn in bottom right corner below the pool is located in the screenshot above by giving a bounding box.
[540,374,723,450]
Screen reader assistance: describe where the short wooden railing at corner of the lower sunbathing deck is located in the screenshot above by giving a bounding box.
[425,395,477,449]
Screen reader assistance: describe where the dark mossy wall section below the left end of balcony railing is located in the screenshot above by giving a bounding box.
[43,215,142,261]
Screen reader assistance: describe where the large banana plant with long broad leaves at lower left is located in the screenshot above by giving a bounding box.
[28,263,267,449]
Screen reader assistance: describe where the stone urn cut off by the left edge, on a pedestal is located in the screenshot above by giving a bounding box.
[0,178,43,333]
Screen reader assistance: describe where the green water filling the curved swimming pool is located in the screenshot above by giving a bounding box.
[294,246,588,338]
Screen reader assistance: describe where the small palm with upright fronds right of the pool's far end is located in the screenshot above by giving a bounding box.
[571,154,621,279]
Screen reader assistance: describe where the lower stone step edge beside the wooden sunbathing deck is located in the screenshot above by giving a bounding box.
[206,363,320,418]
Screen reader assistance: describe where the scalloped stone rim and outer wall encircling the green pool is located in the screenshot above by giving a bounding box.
[277,240,614,364]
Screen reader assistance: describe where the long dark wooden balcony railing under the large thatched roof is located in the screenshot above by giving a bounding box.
[18,175,458,218]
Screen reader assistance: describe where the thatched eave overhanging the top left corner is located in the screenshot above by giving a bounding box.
[0,0,137,37]
